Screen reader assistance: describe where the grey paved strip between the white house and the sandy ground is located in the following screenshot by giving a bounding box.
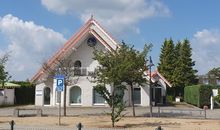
[0,105,220,119]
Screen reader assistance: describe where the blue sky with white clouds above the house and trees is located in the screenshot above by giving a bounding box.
[0,0,220,80]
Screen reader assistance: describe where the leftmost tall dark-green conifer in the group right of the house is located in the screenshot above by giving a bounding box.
[158,38,175,81]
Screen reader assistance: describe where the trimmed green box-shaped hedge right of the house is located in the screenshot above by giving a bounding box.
[184,85,214,107]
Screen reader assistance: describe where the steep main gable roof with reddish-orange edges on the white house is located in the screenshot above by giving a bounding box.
[31,17,119,82]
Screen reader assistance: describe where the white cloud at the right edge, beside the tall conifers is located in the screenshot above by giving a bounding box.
[192,29,220,74]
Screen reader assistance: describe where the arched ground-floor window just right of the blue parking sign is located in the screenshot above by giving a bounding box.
[70,86,82,104]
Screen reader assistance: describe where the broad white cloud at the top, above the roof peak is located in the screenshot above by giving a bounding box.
[41,0,170,34]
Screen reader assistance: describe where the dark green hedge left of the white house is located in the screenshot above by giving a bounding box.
[13,81,35,105]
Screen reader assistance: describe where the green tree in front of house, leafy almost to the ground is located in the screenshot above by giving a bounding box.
[94,48,127,127]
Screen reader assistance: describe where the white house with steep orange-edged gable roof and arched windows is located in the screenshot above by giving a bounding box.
[31,18,171,106]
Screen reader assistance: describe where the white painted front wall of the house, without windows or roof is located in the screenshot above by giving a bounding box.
[35,31,157,106]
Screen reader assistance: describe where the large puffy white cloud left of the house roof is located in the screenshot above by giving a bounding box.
[0,14,66,80]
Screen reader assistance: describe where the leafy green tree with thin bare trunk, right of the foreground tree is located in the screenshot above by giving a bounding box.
[121,43,152,116]
